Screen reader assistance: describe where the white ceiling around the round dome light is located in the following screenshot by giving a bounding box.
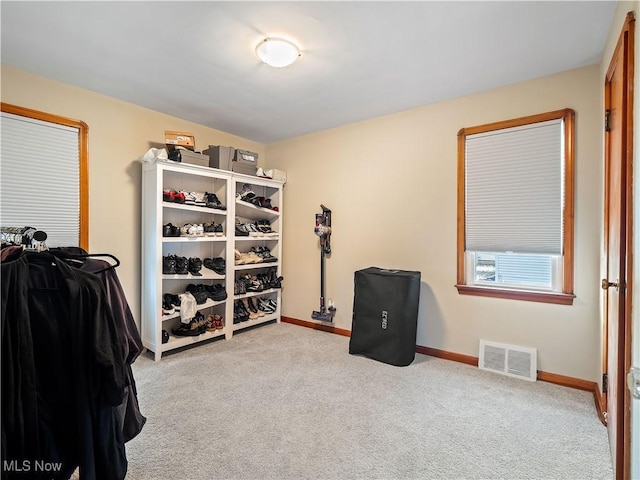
[0,0,616,143]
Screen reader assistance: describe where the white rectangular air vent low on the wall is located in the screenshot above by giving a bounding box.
[478,340,538,382]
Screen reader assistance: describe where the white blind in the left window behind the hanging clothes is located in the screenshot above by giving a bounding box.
[0,112,80,247]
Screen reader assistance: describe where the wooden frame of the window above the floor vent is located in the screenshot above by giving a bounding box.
[456,108,575,305]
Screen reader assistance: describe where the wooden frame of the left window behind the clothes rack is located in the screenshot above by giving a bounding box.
[0,102,89,251]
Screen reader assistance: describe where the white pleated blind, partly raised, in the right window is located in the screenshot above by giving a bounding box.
[465,119,564,255]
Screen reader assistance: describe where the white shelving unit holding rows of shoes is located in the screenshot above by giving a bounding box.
[141,161,283,361]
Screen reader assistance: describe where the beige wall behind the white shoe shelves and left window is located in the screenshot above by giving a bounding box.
[1,65,264,324]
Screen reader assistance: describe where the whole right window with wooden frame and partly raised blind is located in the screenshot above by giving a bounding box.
[456,109,575,305]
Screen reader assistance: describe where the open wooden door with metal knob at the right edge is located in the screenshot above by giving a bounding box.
[602,13,634,479]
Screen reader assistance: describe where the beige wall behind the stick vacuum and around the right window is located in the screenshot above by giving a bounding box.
[266,66,602,381]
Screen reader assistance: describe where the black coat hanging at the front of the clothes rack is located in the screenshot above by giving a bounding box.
[0,253,127,480]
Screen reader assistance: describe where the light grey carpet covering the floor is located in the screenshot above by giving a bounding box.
[127,323,613,480]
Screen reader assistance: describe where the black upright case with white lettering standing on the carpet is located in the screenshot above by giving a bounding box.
[349,267,420,366]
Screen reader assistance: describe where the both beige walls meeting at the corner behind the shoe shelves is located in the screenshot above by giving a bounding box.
[2,62,602,380]
